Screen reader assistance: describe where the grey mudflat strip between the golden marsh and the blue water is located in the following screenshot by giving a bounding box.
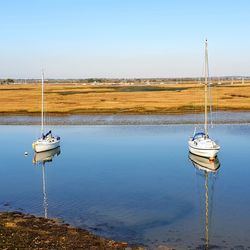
[0,112,250,125]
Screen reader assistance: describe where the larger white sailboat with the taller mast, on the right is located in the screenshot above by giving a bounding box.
[188,40,220,159]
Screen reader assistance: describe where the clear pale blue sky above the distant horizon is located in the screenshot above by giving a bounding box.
[0,0,250,78]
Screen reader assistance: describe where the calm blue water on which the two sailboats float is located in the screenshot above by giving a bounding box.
[0,124,250,249]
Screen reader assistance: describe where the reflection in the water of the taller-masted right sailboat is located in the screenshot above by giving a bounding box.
[189,153,220,250]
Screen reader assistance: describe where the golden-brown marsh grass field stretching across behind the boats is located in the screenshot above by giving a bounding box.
[0,82,250,115]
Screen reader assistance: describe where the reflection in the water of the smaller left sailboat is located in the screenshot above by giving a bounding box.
[33,147,61,218]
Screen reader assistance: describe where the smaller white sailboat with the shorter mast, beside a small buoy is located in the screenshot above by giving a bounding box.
[32,72,60,152]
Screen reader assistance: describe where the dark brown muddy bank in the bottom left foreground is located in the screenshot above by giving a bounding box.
[0,212,144,250]
